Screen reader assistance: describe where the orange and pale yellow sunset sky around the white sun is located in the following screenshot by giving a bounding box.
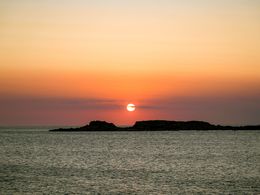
[0,0,260,126]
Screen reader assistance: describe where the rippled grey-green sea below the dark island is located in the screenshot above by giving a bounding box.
[0,128,260,194]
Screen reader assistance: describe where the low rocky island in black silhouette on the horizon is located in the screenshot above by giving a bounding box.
[50,120,260,131]
